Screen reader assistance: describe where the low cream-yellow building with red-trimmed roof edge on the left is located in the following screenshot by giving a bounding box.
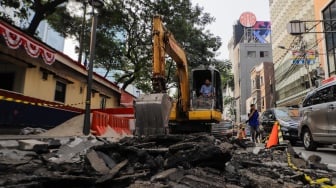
[0,21,121,125]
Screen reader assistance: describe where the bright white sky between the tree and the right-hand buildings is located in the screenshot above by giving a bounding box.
[191,0,270,59]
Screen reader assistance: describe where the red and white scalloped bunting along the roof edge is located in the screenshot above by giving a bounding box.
[0,22,55,65]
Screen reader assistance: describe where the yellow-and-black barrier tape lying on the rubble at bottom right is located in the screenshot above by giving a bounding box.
[287,151,336,188]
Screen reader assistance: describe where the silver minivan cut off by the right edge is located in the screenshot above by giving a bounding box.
[299,81,336,150]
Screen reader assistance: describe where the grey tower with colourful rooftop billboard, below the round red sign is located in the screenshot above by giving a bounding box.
[228,22,272,122]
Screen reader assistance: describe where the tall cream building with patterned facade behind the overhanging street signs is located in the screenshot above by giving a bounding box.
[269,0,319,106]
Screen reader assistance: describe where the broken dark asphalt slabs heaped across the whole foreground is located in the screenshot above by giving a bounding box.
[0,134,336,188]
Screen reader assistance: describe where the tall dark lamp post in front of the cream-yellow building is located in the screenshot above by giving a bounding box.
[83,0,104,135]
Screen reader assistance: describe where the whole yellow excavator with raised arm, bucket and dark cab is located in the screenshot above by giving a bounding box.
[135,15,223,135]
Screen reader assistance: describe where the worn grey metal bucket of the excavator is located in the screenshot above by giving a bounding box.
[135,93,172,135]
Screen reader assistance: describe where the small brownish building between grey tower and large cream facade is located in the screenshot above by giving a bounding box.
[246,62,275,112]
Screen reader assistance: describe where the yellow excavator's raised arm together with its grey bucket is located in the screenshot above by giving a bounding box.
[135,16,190,135]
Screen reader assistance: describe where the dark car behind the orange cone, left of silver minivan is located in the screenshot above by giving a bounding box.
[260,107,300,144]
